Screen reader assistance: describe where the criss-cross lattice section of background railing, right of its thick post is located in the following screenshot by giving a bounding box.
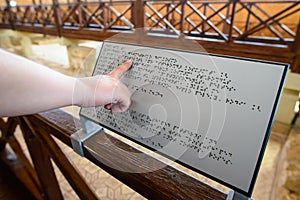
[145,0,300,46]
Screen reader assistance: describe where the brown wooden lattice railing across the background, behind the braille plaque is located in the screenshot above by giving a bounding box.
[0,0,300,72]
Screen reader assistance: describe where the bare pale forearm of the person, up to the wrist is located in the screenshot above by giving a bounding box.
[0,49,78,117]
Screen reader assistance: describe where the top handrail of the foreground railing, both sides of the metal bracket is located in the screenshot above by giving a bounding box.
[26,110,226,200]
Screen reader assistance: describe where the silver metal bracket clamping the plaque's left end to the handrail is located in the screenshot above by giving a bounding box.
[70,116,103,157]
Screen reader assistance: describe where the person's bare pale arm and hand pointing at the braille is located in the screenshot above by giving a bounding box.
[0,49,132,117]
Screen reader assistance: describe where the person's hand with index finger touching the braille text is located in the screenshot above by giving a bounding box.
[73,60,132,112]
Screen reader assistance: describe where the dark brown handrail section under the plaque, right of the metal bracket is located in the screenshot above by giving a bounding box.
[84,132,226,200]
